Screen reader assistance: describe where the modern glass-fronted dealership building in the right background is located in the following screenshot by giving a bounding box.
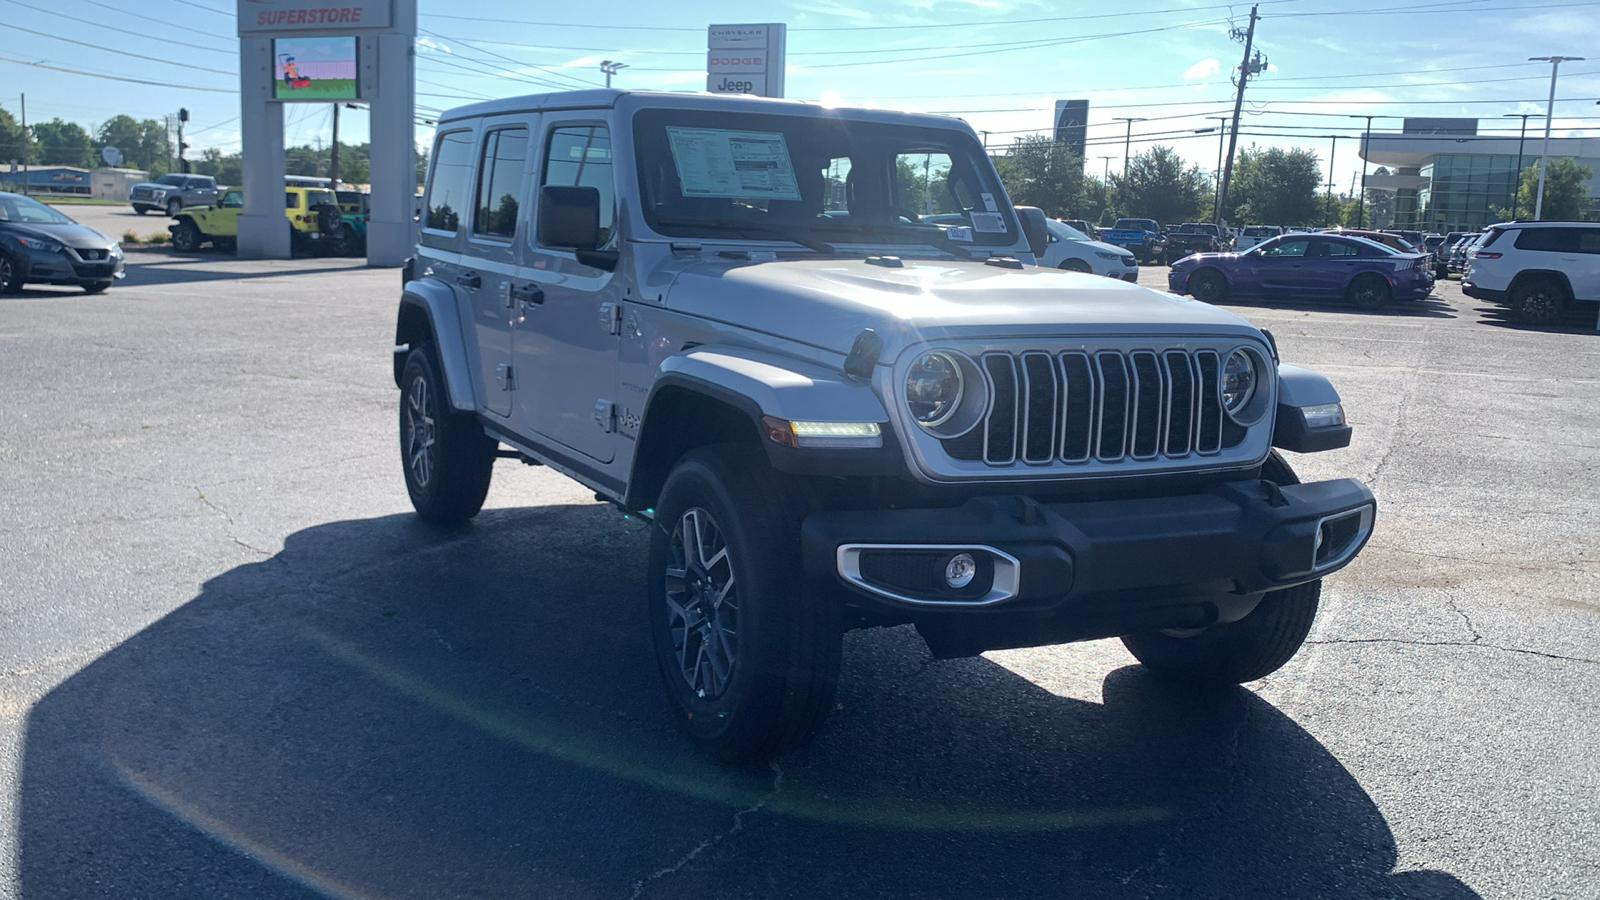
[1362,119,1600,232]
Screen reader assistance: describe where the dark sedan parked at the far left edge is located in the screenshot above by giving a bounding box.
[0,192,122,293]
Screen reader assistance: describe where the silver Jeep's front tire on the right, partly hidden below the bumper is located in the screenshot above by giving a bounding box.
[1122,450,1322,687]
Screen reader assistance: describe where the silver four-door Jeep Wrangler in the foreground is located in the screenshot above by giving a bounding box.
[394,90,1376,761]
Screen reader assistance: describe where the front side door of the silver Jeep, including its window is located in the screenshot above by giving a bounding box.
[512,114,624,463]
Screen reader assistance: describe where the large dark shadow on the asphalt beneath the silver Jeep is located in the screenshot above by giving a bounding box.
[18,506,1475,900]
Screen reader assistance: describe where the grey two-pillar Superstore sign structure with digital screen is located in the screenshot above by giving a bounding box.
[238,0,418,266]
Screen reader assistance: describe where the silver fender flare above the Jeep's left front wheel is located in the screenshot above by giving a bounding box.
[658,346,890,429]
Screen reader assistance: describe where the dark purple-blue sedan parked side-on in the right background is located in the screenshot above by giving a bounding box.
[1166,234,1434,309]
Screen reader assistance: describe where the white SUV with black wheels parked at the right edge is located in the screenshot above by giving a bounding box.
[1461,223,1600,325]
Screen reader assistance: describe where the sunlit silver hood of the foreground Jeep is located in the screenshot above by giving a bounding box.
[666,258,1256,360]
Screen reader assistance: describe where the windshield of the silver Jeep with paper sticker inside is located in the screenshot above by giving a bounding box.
[634,109,1019,253]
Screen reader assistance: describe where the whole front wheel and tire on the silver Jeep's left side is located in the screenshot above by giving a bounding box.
[646,445,843,762]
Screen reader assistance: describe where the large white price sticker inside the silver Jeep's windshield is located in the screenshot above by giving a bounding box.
[667,125,800,200]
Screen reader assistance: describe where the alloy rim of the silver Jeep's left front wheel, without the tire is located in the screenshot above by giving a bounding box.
[666,506,739,700]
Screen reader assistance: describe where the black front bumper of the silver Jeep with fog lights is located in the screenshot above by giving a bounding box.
[802,479,1378,649]
